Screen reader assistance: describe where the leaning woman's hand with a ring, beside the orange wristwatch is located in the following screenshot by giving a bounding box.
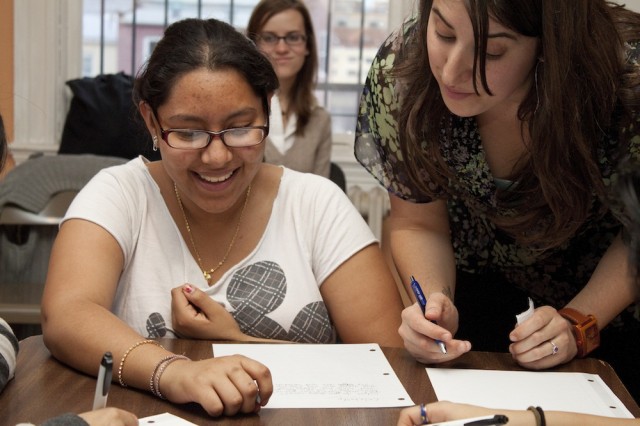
[509,306,578,370]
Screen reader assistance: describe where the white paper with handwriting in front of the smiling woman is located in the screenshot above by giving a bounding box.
[213,343,414,408]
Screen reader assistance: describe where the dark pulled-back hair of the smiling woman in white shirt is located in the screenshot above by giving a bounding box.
[133,18,279,117]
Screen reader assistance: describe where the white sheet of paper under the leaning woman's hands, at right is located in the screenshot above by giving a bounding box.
[426,368,633,418]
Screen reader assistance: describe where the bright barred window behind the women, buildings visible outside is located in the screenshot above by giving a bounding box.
[82,0,390,133]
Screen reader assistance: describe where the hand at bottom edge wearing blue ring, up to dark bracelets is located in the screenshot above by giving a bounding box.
[398,401,516,426]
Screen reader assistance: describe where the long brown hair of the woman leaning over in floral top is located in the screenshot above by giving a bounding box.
[396,0,640,250]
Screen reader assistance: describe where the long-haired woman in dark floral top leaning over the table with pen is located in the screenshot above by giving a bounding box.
[356,0,640,398]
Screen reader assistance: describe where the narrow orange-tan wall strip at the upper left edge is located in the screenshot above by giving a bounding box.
[0,0,14,141]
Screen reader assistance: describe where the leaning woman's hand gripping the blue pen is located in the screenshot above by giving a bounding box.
[398,293,471,364]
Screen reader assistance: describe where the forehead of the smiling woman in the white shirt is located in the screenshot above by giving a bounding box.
[160,68,261,113]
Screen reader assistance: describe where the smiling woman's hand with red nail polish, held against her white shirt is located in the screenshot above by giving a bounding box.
[171,284,247,341]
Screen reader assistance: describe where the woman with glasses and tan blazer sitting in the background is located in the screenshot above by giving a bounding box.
[247,0,332,177]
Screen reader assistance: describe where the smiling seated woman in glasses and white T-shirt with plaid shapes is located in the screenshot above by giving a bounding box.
[42,15,402,415]
